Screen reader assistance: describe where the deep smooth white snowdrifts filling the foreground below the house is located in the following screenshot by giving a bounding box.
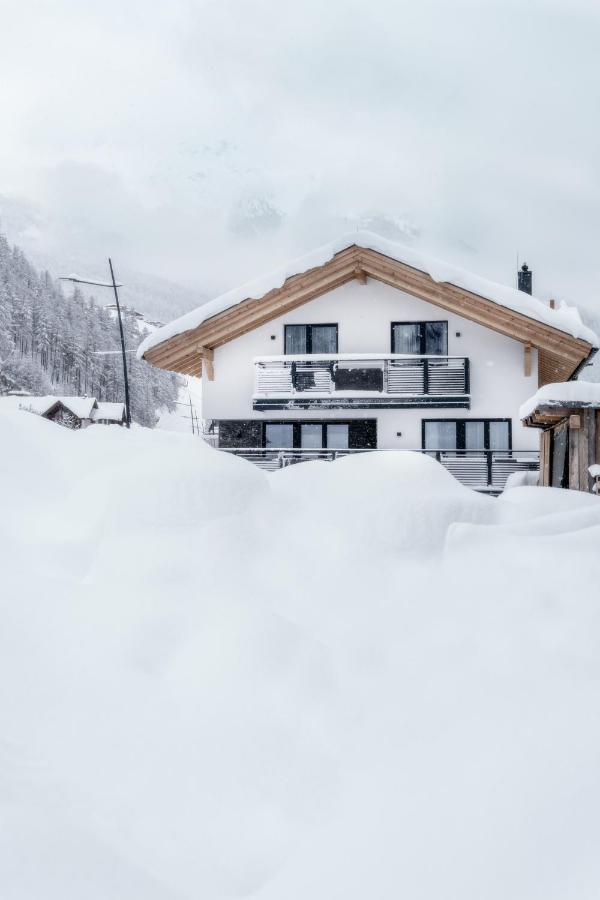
[0,412,600,900]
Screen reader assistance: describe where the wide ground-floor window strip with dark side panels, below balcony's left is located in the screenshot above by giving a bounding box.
[218,419,377,450]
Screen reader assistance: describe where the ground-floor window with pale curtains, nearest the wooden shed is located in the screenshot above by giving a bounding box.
[422,419,512,450]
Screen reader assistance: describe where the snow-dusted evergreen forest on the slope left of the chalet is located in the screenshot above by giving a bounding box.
[0,229,179,427]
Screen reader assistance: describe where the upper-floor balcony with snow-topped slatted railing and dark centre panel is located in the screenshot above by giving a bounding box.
[253,354,470,411]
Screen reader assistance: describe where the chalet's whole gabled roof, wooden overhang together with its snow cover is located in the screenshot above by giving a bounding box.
[138,231,599,378]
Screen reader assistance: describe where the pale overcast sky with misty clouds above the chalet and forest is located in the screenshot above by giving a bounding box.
[0,0,600,313]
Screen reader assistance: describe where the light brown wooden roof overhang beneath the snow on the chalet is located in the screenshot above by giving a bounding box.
[144,246,593,384]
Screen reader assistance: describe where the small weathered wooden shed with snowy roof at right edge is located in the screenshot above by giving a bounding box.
[520,381,600,493]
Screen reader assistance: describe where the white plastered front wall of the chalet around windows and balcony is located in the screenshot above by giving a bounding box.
[202,279,538,450]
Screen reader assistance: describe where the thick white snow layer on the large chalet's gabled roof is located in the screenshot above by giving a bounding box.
[137,231,599,359]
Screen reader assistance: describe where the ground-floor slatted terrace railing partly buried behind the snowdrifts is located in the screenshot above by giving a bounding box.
[220,447,539,494]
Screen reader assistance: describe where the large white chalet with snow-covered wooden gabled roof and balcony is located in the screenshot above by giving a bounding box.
[138,232,598,492]
